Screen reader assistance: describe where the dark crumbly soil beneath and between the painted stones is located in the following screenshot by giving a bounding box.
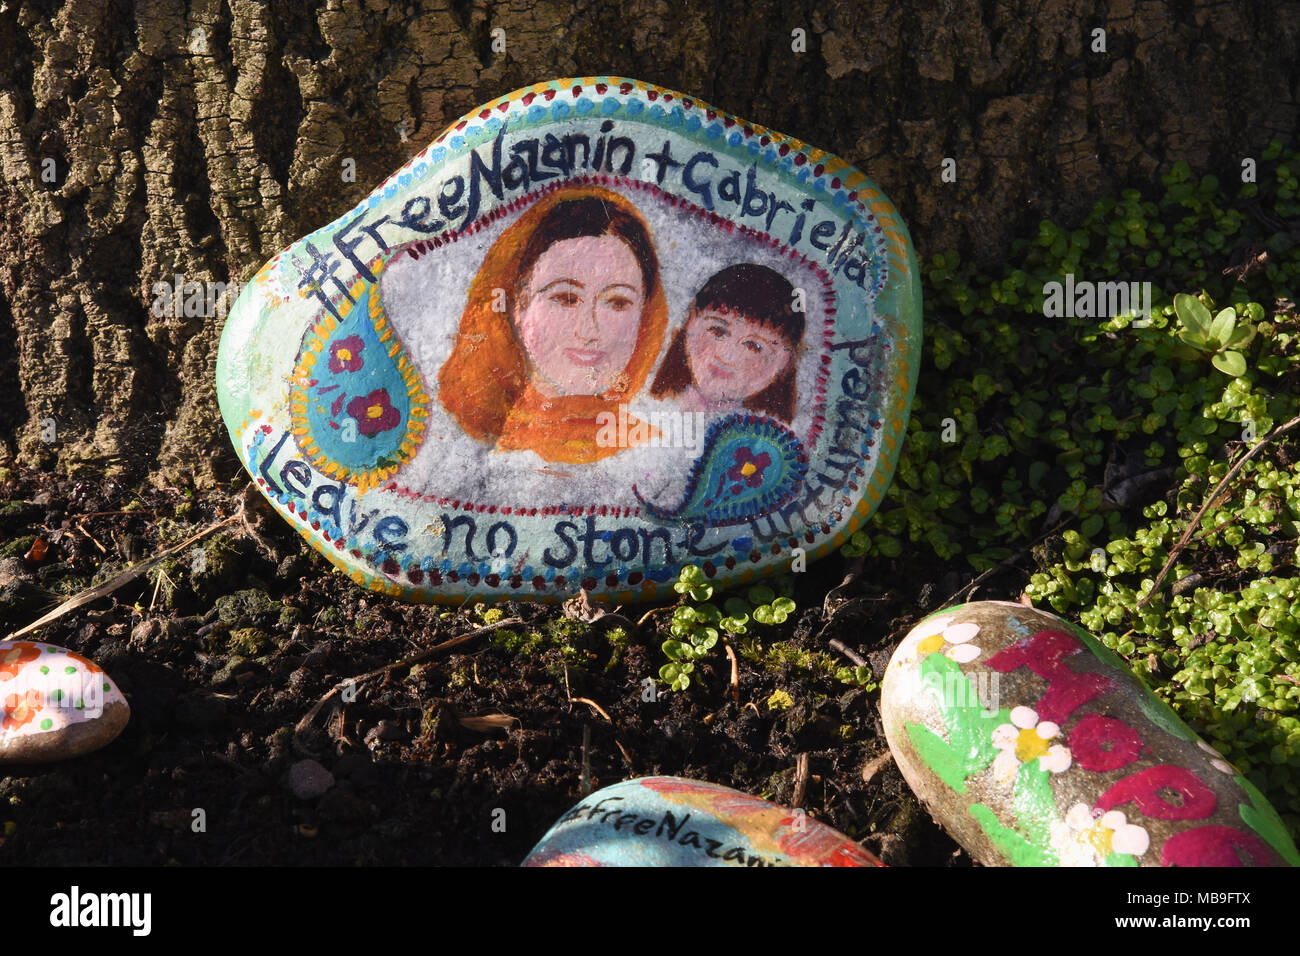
[0,465,977,866]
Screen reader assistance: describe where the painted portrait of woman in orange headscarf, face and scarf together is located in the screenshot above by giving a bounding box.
[438,186,668,464]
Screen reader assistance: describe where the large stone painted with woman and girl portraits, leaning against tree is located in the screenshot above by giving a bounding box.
[217,77,920,602]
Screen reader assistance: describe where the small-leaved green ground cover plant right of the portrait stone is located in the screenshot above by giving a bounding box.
[842,142,1300,832]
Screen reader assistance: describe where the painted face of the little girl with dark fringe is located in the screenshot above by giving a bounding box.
[686,308,793,402]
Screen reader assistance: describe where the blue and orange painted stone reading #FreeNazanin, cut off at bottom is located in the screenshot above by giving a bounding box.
[524,777,884,866]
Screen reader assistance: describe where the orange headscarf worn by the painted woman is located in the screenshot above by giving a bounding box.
[438,186,668,464]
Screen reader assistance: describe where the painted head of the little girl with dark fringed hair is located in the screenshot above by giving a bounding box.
[650,263,803,424]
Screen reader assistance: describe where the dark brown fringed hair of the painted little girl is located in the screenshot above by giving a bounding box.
[650,263,803,423]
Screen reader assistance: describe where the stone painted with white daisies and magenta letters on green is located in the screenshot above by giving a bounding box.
[881,601,1300,866]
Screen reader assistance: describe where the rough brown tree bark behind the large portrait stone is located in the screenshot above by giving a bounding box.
[0,0,1300,486]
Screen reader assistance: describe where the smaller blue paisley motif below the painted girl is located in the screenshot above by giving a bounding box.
[632,414,807,527]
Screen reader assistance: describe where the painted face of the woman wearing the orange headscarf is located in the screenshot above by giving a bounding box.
[516,235,646,395]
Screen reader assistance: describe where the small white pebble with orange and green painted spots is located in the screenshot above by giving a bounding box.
[0,641,131,763]
